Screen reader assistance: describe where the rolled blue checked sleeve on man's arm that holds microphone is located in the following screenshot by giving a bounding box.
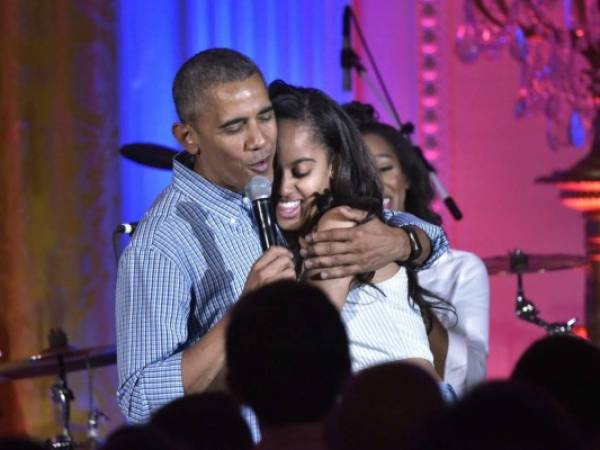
[116,247,191,422]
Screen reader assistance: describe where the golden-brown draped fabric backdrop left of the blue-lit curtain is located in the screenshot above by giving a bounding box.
[0,0,119,438]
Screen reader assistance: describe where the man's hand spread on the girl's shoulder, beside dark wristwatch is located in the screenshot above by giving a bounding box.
[301,206,431,278]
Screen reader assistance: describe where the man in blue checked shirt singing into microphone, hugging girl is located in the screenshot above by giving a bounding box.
[116,49,447,422]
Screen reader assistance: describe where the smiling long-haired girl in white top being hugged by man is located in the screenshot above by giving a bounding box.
[269,81,448,380]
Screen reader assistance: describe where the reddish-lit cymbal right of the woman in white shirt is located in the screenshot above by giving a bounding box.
[483,251,588,275]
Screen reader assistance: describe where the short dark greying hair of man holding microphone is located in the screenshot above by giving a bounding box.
[173,48,264,123]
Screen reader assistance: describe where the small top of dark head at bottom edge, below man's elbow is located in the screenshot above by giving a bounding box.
[102,425,180,450]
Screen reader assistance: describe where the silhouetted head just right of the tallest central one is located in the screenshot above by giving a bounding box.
[327,362,445,450]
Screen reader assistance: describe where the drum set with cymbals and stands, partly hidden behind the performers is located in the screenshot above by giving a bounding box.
[0,144,588,449]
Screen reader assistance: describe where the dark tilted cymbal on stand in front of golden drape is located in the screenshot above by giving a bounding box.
[0,345,117,383]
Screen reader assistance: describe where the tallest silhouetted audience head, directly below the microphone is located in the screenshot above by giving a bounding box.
[226,281,350,427]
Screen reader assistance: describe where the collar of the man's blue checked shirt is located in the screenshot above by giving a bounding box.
[173,152,251,218]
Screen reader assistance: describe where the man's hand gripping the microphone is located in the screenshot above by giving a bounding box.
[242,246,296,295]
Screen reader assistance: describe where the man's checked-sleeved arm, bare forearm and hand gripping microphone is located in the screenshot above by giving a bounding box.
[116,247,295,422]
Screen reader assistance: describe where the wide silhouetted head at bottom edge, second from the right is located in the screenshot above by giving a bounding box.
[412,381,583,450]
